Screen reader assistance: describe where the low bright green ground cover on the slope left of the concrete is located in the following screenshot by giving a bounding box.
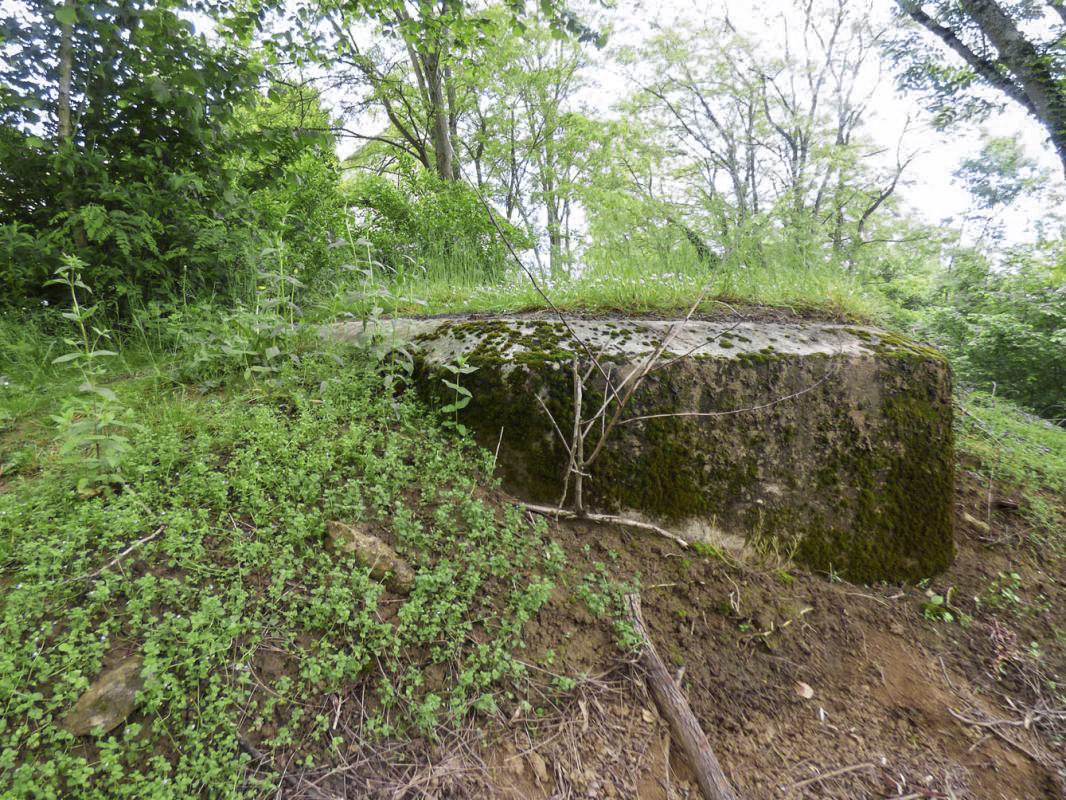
[0,352,563,798]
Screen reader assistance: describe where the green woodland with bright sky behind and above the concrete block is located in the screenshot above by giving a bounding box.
[0,0,1066,426]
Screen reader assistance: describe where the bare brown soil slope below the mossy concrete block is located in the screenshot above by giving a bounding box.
[245,466,1066,800]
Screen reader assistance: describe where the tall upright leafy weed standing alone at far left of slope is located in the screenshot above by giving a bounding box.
[45,255,139,495]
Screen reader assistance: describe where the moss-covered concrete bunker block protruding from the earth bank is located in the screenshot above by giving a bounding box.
[335,317,954,581]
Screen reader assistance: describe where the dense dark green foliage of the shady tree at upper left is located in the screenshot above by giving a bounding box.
[0,0,271,313]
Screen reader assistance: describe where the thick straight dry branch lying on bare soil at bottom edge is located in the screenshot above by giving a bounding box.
[626,594,739,800]
